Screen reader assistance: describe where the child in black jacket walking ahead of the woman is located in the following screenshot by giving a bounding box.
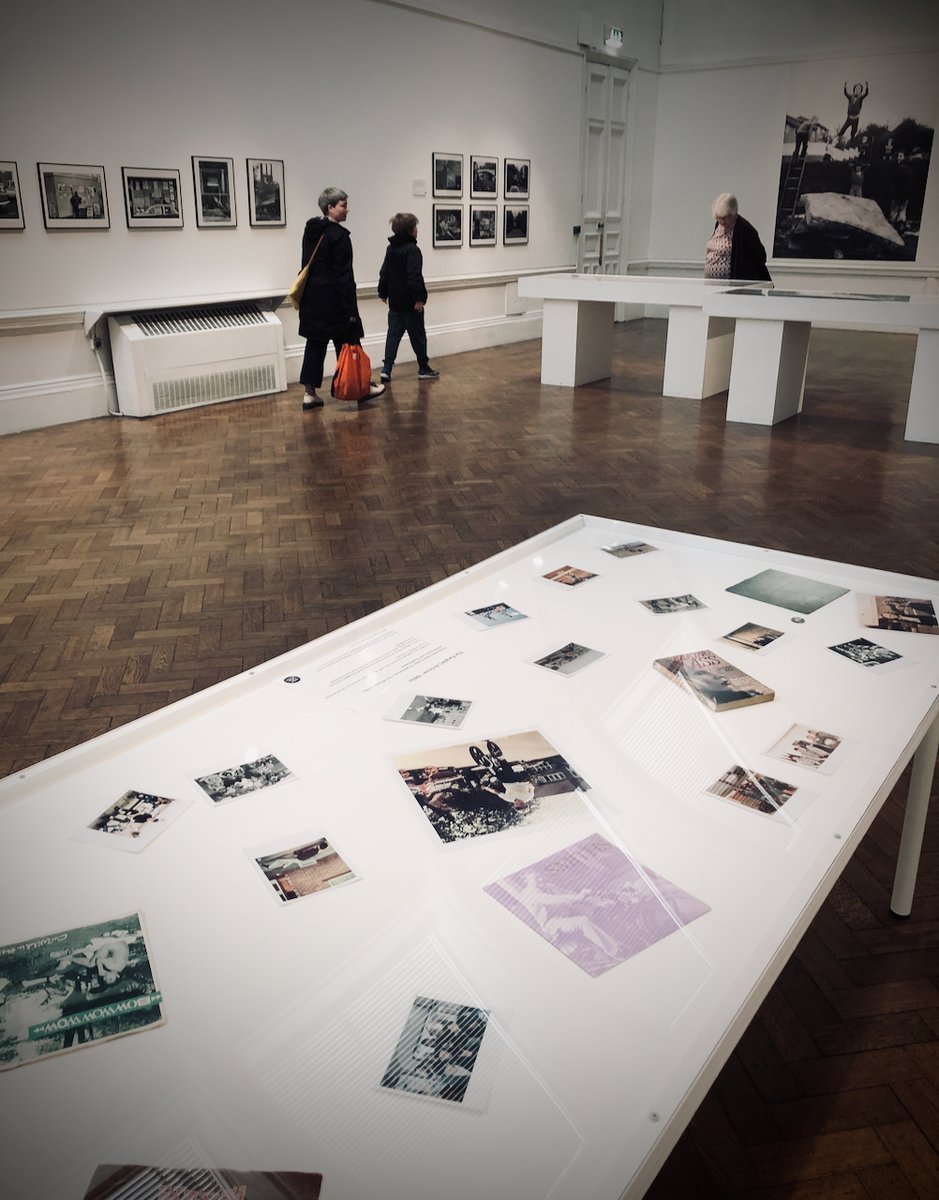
[378,212,439,383]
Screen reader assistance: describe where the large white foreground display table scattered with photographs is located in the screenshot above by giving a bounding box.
[0,517,939,1200]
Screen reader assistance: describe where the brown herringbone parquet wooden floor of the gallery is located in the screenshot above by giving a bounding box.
[0,320,939,1200]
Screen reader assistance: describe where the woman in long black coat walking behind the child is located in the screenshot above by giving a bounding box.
[299,187,384,412]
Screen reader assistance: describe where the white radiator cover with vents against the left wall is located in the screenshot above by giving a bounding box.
[108,304,287,416]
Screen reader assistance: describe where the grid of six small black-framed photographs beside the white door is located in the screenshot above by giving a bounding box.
[432,152,532,248]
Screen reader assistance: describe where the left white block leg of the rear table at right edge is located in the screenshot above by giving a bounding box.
[726,317,812,425]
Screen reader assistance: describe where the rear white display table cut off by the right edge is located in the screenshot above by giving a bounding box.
[704,286,939,442]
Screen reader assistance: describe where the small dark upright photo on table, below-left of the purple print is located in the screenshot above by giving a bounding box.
[381,996,490,1111]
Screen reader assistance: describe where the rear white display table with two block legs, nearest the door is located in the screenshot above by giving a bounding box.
[519,275,734,400]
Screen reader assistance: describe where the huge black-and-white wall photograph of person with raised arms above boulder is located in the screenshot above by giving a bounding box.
[767,55,939,261]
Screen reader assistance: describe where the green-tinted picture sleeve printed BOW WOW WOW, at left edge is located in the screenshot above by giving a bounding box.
[0,913,165,1070]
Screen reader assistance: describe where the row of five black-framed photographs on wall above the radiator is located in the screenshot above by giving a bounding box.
[0,155,287,232]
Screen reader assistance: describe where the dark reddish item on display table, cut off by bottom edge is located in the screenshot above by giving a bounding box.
[84,1163,323,1200]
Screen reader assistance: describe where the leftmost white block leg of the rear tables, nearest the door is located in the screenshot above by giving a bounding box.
[542,300,614,388]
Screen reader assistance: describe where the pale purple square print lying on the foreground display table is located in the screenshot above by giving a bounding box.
[484,833,710,977]
